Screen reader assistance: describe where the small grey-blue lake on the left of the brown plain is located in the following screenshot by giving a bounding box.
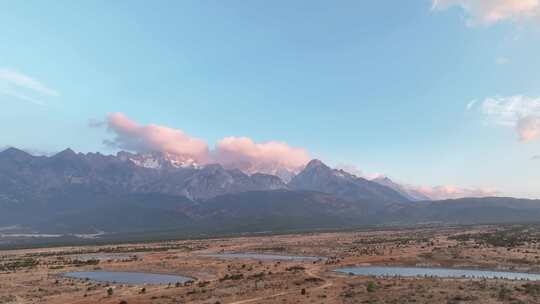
[63,271,193,284]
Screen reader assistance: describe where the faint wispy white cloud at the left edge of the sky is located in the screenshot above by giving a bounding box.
[0,68,60,105]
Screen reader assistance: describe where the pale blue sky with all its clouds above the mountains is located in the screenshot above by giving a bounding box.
[0,0,540,198]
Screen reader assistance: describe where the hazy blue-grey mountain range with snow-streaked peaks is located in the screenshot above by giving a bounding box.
[0,148,540,233]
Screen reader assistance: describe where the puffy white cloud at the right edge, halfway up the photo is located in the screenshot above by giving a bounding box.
[481,95,540,141]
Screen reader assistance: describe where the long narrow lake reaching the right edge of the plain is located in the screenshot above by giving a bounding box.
[336,266,540,281]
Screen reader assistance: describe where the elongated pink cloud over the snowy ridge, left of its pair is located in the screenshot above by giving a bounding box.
[106,113,208,163]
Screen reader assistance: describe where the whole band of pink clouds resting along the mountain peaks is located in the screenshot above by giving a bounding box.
[101,113,310,174]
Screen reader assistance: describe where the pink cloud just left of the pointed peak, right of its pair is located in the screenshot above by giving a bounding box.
[213,137,310,173]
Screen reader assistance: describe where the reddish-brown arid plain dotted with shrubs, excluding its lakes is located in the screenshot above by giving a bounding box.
[0,225,540,304]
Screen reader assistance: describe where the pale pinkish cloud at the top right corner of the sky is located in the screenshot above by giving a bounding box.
[432,0,540,26]
